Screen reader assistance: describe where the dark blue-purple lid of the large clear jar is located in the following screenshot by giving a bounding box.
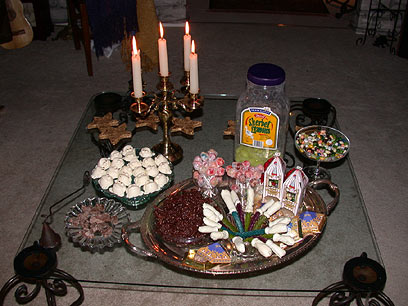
[247,63,285,86]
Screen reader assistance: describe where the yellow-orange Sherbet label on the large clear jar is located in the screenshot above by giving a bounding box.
[240,107,279,149]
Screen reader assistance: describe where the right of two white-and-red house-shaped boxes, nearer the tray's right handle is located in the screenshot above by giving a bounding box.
[280,167,309,216]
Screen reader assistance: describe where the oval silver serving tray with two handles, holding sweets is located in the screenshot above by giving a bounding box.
[122,179,340,275]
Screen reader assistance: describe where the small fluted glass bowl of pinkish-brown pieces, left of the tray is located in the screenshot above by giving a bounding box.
[65,198,130,252]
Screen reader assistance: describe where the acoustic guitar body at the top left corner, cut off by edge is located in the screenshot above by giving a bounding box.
[0,0,34,49]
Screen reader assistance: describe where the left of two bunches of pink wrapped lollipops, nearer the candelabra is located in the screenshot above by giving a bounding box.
[193,149,225,198]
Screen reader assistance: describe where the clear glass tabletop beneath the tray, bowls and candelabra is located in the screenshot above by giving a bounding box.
[20,95,381,296]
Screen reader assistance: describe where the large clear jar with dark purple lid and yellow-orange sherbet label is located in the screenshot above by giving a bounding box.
[235,63,290,166]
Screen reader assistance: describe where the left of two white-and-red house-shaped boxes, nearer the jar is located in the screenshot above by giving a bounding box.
[263,152,286,203]
